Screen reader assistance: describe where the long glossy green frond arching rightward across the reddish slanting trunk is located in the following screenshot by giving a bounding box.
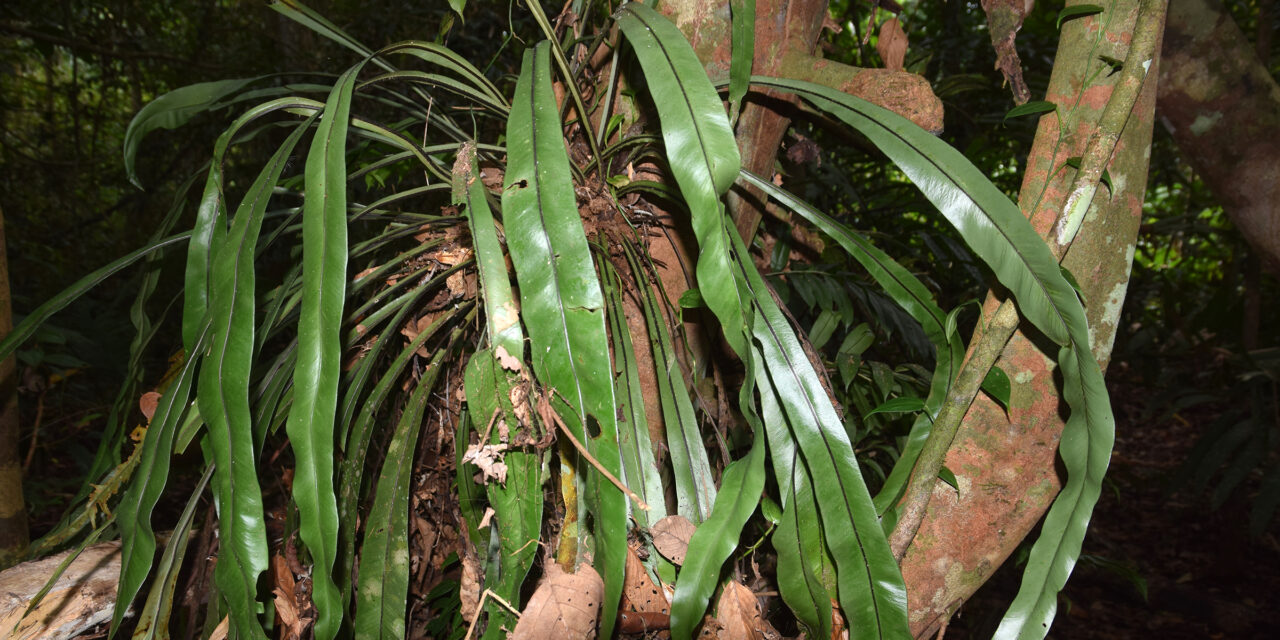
[753,77,1115,637]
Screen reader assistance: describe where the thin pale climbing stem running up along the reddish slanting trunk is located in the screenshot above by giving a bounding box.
[888,0,1165,562]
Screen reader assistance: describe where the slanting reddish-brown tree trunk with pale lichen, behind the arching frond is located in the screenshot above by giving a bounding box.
[902,0,1162,637]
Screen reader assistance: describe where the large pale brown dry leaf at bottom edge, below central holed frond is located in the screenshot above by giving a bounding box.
[511,563,604,640]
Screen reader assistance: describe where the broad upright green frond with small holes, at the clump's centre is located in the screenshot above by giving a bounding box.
[502,42,627,637]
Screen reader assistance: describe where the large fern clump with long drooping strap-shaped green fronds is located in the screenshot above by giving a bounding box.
[0,0,1152,640]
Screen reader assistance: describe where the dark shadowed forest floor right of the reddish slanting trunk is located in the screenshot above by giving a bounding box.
[946,366,1280,640]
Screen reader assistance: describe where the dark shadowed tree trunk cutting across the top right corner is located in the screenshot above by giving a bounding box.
[1158,0,1280,275]
